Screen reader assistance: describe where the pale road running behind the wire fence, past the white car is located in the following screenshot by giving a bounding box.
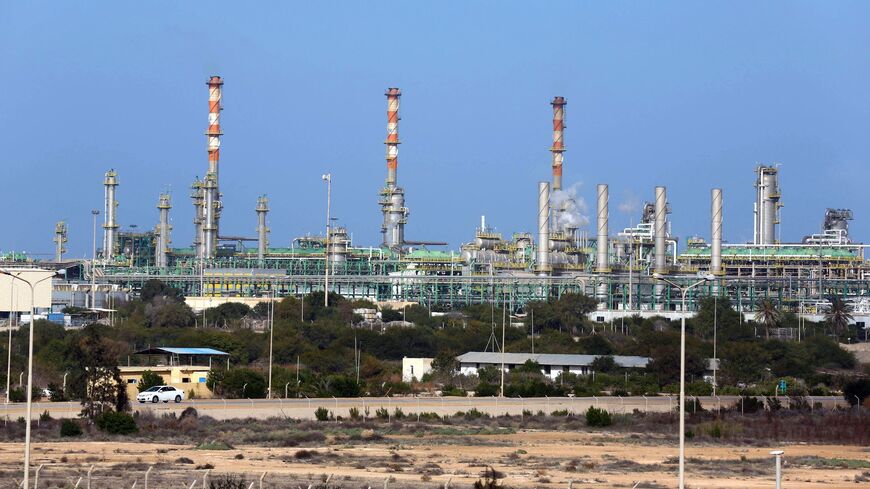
[2,396,848,420]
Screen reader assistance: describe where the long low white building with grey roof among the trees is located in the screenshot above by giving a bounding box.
[456,351,650,380]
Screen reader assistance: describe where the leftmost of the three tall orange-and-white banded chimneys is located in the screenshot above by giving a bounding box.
[204,76,224,258]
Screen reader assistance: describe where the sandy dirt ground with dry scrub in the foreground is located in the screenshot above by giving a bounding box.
[0,431,870,489]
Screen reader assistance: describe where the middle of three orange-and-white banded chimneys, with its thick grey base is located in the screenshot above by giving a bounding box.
[379,88,408,249]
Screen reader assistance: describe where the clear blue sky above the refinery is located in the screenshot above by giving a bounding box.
[0,1,870,256]
